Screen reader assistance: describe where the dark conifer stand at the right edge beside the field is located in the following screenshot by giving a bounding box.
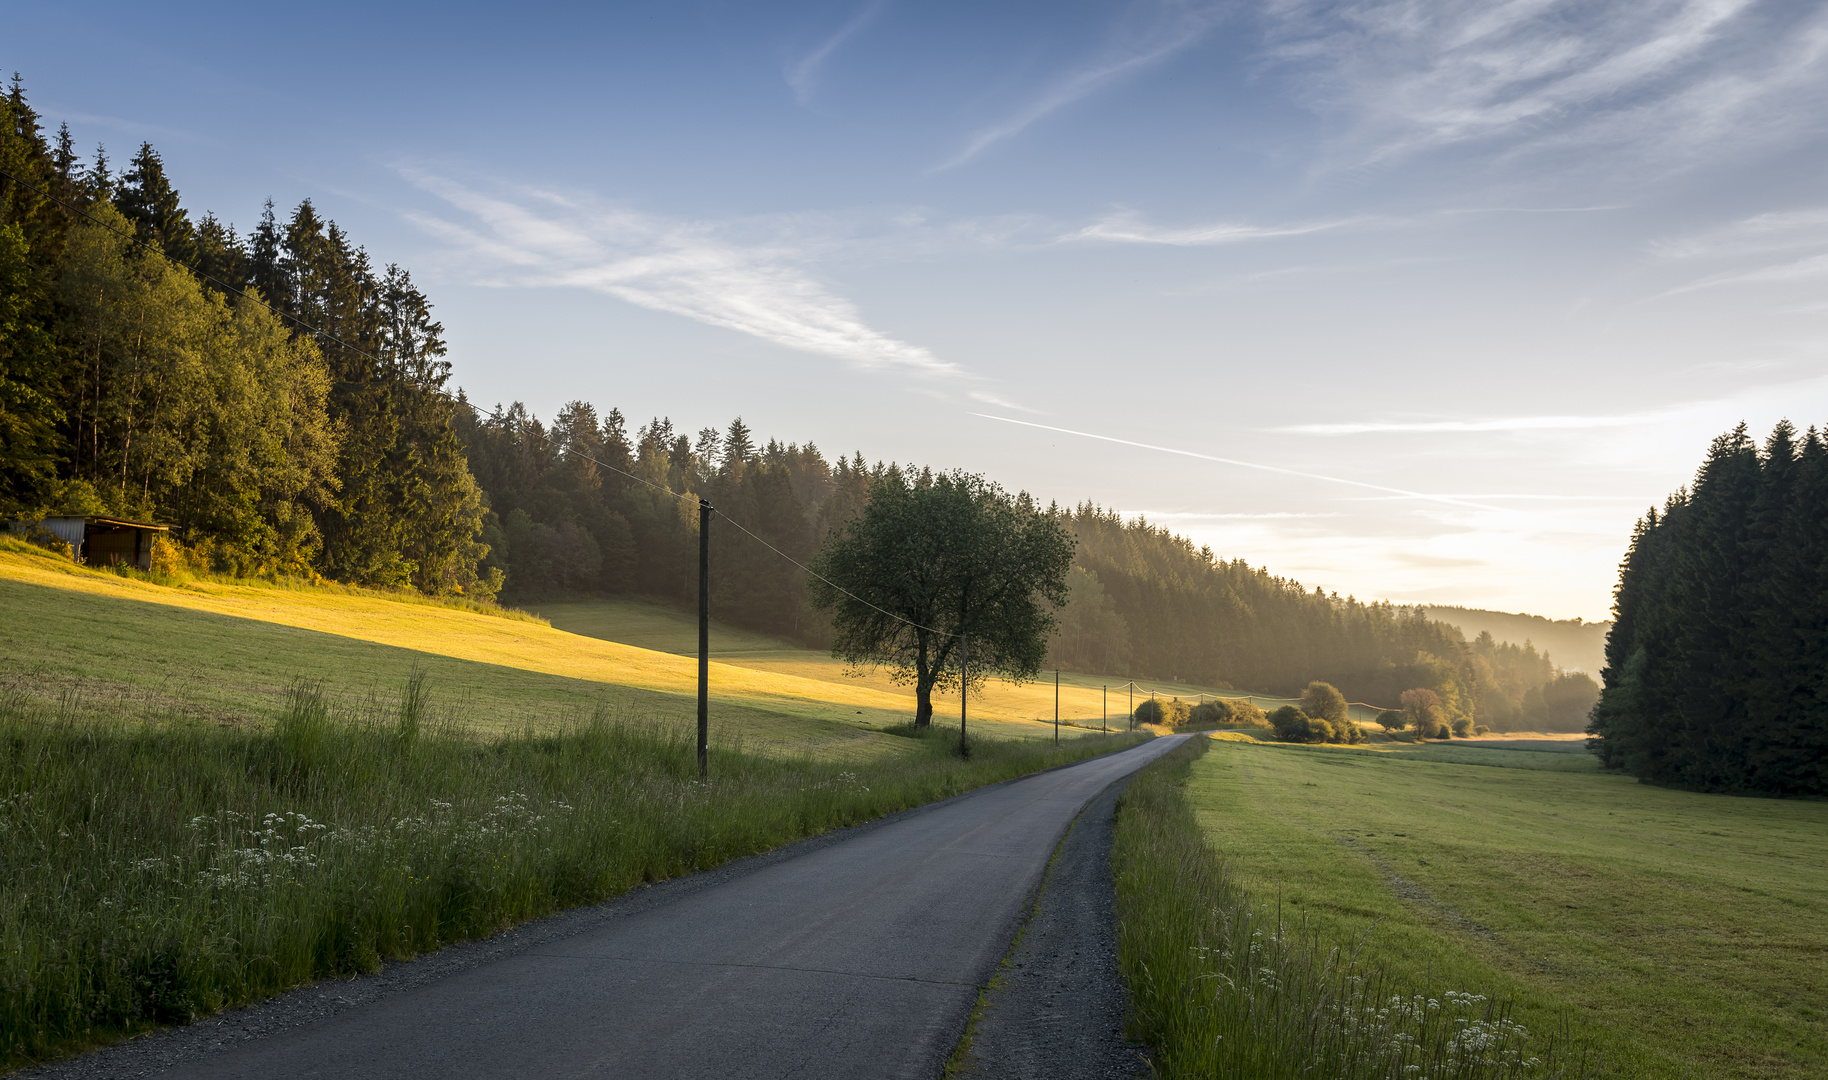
[1589,422,1828,795]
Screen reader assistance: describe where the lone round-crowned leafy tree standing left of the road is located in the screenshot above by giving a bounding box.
[812,471,1073,727]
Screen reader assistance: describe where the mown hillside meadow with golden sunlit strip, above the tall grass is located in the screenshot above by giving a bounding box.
[0,539,1096,757]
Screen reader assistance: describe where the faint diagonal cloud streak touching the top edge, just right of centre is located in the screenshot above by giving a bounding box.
[934,0,1228,172]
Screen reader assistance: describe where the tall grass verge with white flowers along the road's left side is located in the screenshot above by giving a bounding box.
[0,671,1132,1065]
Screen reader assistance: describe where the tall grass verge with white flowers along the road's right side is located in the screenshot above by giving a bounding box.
[1113,738,1592,1080]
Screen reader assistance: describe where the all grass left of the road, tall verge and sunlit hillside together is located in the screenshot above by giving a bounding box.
[0,541,1144,1067]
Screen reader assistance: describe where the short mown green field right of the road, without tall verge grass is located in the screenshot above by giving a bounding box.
[1186,740,1828,1080]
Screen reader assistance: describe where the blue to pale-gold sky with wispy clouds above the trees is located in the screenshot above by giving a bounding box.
[14,0,1828,619]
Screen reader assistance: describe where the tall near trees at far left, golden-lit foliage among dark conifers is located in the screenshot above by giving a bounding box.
[0,79,499,596]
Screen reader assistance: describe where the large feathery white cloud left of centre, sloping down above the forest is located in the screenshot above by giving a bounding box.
[408,172,972,381]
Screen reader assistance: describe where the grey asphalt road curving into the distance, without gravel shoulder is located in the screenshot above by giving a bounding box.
[114,738,1179,1080]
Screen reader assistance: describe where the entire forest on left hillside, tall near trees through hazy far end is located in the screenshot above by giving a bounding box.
[0,79,1598,731]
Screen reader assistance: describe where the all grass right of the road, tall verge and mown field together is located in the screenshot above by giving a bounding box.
[1117,735,1828,1080]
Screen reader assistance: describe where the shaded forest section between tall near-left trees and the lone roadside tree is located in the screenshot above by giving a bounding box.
[457,402,873,643]
